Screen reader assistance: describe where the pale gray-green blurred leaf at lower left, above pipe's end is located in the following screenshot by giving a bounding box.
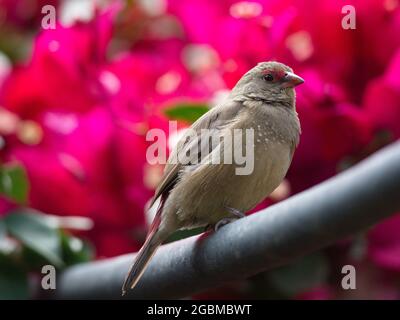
[5,209,64,268]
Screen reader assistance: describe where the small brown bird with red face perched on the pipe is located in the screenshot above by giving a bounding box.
[122,62,304,294]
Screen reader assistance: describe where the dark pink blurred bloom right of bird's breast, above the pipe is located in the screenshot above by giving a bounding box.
[289,70,372,193]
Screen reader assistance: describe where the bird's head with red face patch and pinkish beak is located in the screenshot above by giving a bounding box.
[232,61,304,105]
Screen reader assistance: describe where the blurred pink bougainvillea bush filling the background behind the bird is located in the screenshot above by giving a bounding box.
[0,0,400,299]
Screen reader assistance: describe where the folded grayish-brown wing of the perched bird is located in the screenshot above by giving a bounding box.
[150,101,243,206]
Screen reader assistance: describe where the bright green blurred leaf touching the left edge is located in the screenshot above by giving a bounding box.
[0,164,29,204]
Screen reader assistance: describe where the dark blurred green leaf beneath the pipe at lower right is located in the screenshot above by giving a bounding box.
[267,253,329,297]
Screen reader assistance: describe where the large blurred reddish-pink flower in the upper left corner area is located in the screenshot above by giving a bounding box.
[0,7,112,118]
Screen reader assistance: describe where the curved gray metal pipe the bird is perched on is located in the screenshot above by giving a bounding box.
[51,142,400,299]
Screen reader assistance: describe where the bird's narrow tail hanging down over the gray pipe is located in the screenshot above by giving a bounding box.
[122,230,163,295]
